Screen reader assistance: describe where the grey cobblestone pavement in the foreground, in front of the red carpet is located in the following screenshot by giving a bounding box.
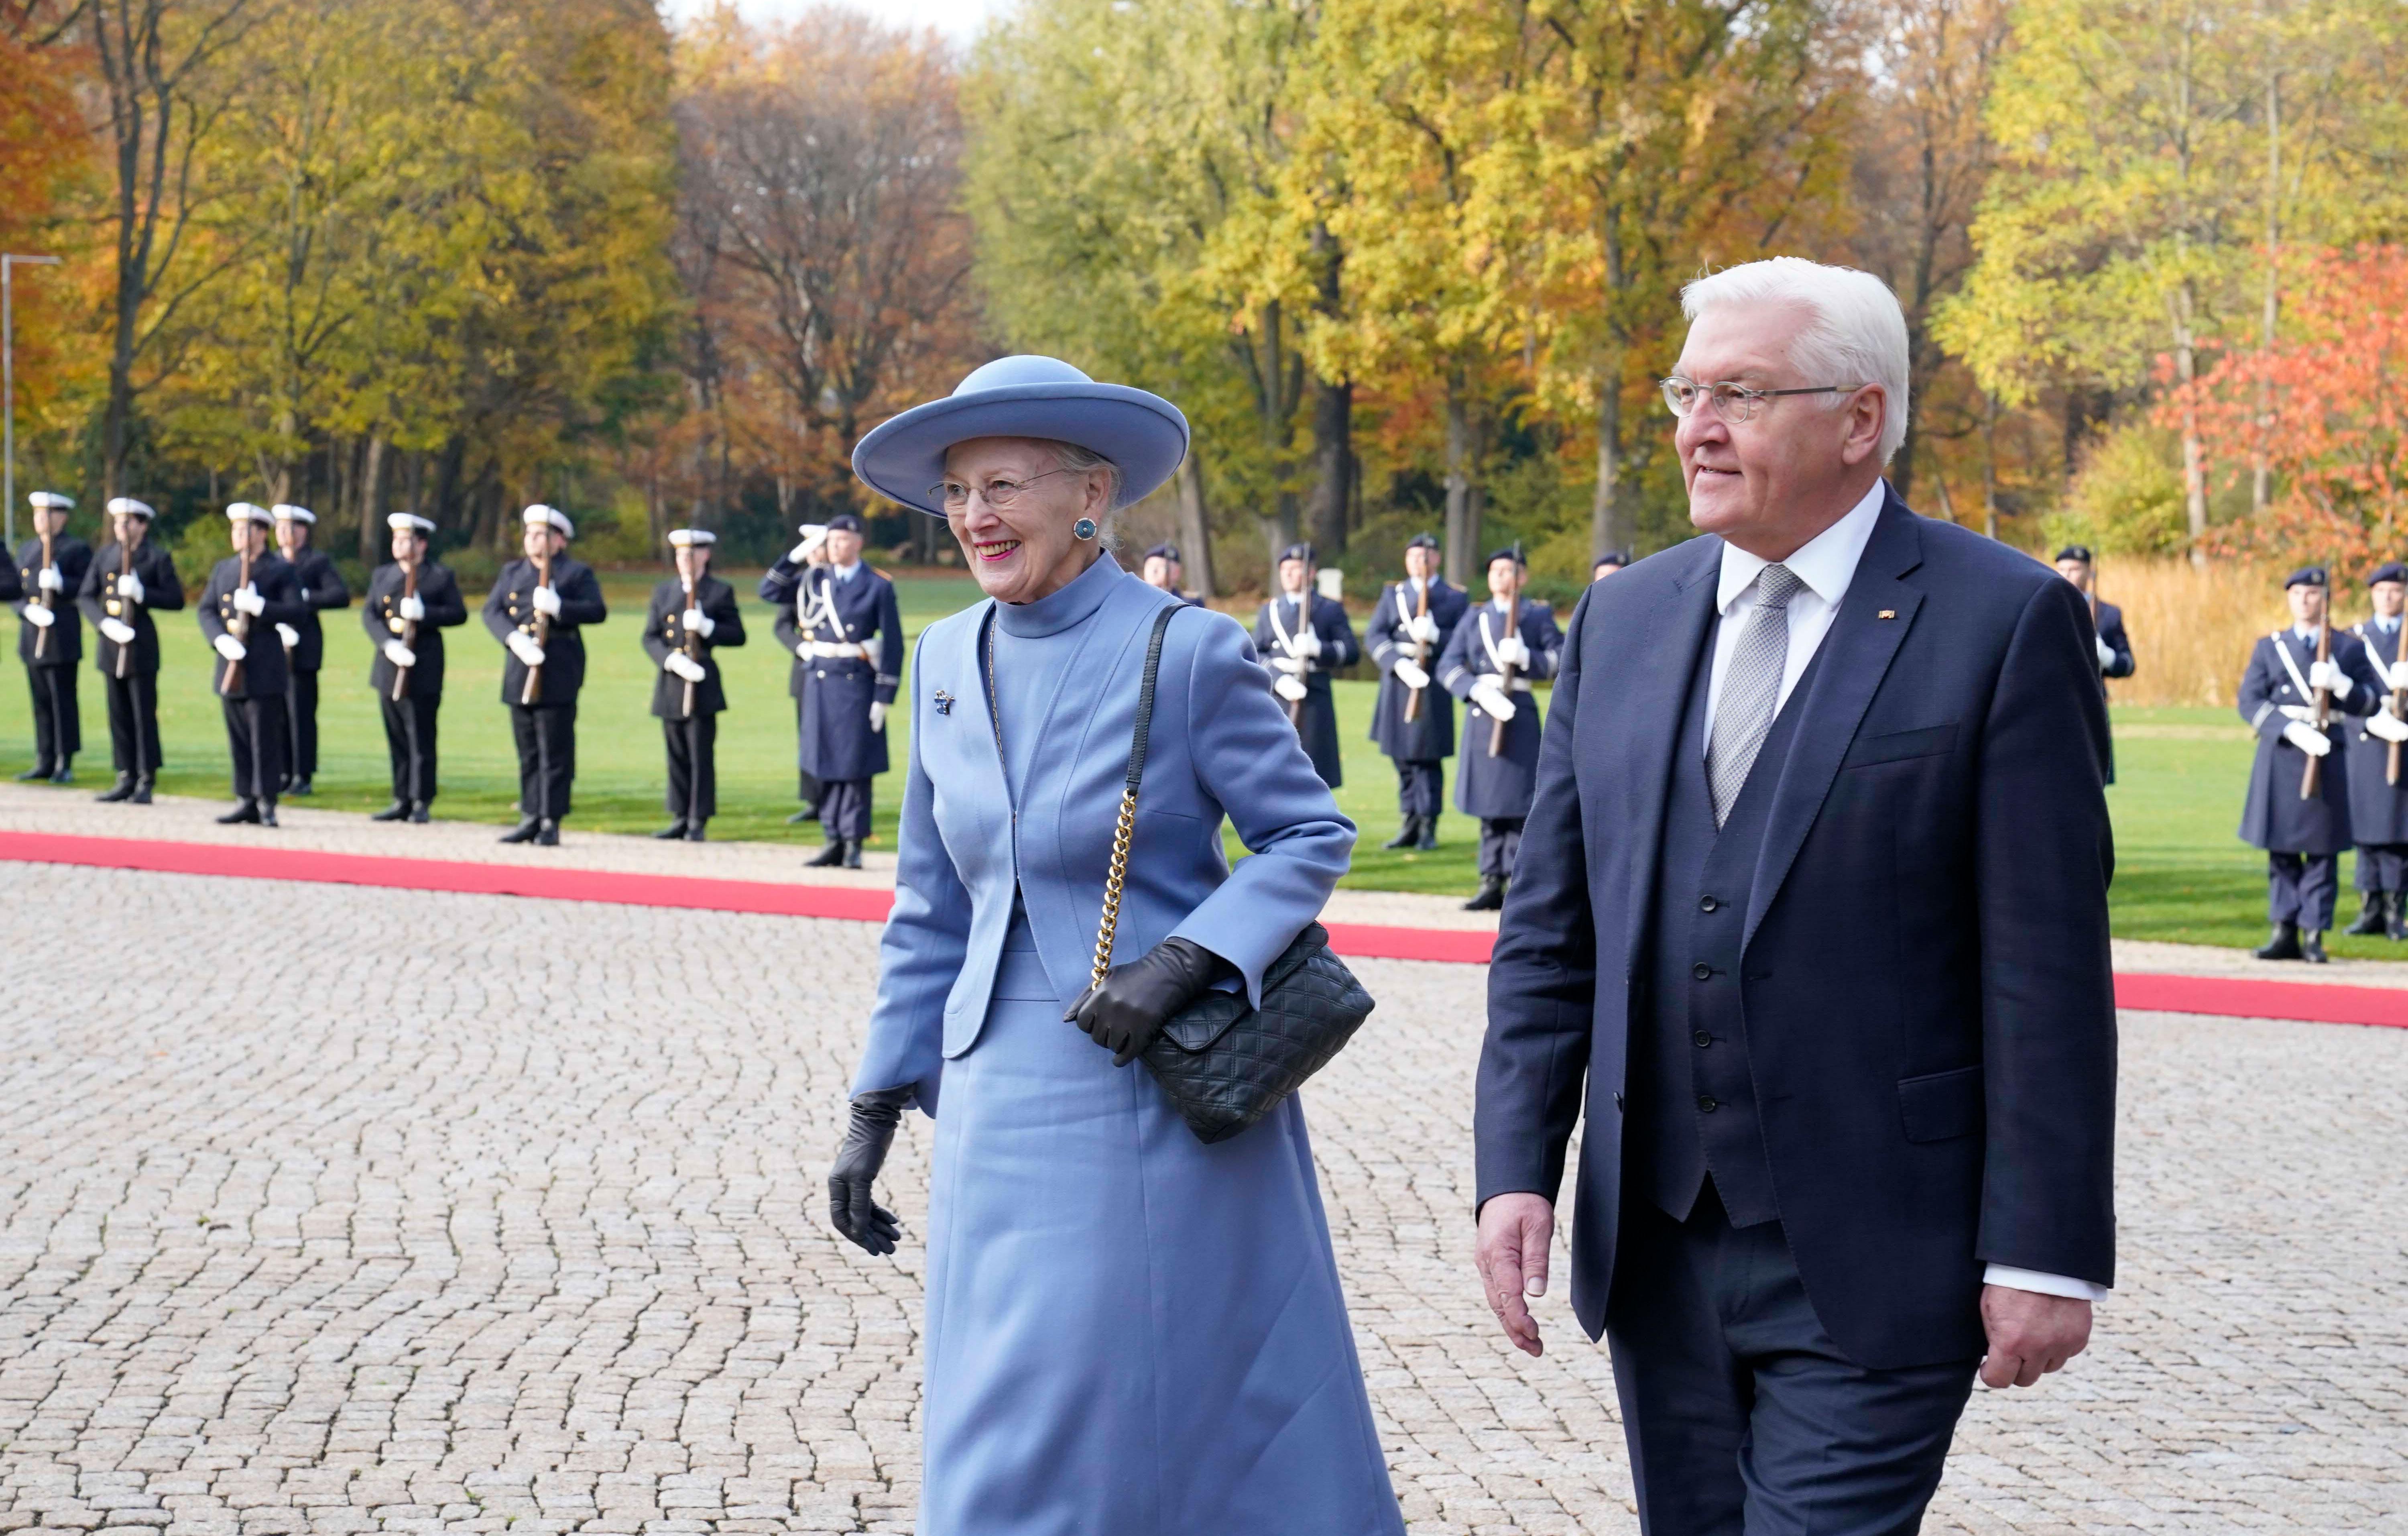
[0,864,2408,1536]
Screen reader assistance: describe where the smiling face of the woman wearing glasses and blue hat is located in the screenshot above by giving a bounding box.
[944,438,1110,602]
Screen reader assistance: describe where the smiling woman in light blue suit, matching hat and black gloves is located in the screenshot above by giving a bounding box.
[828,356,1404,1536]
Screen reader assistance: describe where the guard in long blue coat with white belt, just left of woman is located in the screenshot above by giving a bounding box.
[795,513,903,869]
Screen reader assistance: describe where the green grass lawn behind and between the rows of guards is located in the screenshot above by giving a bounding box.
[0,570,2408,958]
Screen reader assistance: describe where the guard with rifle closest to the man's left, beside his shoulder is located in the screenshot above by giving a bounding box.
[1438,549,1563,913]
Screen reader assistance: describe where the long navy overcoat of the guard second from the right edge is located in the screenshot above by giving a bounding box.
[2225,628,2382,862]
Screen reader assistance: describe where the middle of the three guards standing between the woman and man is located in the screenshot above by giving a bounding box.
[1363,534,1471,847]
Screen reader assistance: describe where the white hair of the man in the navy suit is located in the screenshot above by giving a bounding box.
[1681,255,1907,464]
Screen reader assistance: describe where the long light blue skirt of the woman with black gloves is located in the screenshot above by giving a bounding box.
[920,922,1404,1536]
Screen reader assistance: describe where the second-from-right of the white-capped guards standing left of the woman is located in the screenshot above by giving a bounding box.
[484,503,609,847]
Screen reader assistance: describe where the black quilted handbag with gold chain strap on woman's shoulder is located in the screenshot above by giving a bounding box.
[1093,604,1373,1146]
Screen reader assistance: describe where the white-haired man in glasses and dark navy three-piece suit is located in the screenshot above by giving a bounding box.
[1476,258,2117,1536]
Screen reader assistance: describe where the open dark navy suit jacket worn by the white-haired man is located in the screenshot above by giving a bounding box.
[1476,491,2117,1370]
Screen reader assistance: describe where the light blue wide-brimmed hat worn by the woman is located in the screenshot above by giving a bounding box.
[852,354,1187,517]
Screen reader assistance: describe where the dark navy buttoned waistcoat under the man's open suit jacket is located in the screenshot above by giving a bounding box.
[1623,628,1823,1228]
